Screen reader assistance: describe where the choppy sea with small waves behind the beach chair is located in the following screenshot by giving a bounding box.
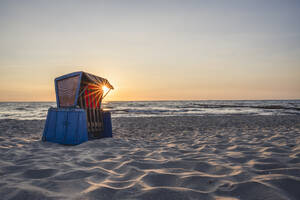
[0,100,300,120]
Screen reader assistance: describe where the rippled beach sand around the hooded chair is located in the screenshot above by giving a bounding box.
[0,115,300,200]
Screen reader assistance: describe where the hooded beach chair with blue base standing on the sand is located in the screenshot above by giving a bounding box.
[42,71,113,145]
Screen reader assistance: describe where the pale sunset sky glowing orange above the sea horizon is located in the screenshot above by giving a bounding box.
[0,0,300,101]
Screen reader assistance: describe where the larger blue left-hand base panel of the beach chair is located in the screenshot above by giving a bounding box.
[42,108,88,145]
